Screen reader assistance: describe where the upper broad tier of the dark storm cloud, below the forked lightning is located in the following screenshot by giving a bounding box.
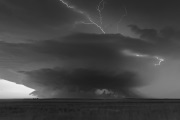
[25,33,159,69]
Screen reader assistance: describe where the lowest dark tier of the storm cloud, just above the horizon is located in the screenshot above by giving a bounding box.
[21,68,143,97]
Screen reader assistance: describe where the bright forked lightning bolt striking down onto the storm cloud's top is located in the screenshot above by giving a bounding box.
[59,0,106,34]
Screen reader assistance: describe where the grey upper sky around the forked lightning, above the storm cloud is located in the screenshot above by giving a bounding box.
[0,0,180,41]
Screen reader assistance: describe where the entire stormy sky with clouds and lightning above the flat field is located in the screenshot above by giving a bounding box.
[0,0,180,99]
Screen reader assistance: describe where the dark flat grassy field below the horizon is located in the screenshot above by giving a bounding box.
[0,99,180,120]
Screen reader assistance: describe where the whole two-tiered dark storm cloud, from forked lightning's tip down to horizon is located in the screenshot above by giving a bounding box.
[8,33,158,97]
